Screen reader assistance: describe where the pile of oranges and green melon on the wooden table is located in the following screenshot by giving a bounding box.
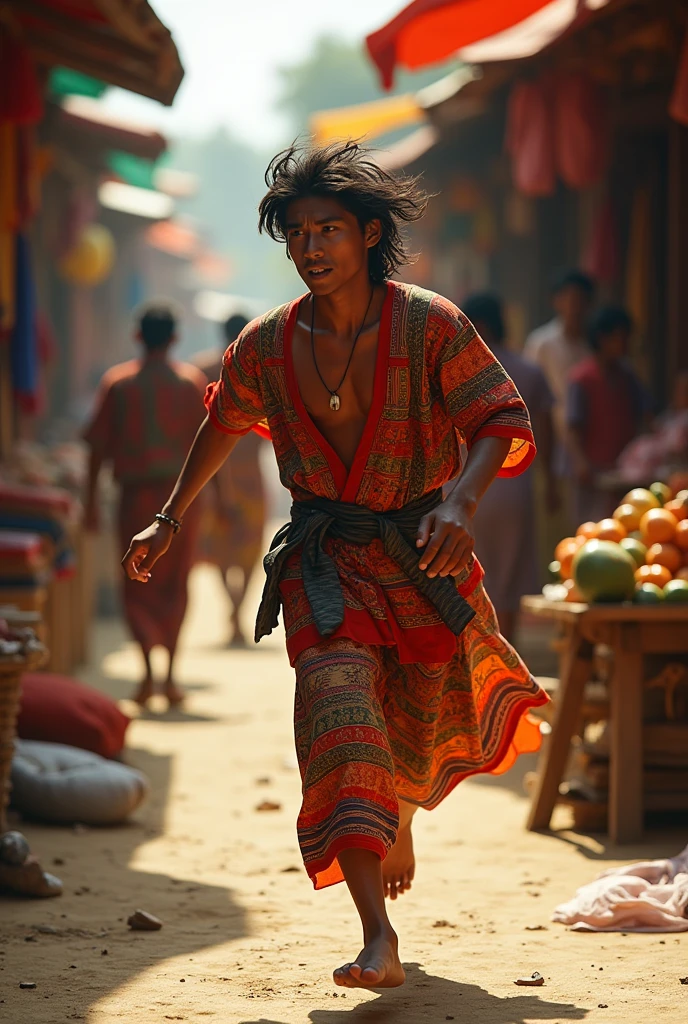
[544,483,688,604]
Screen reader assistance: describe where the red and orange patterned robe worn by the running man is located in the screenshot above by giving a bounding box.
[206,282,547,887]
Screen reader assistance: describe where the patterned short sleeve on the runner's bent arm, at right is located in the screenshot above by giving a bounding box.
[433,307,535,476]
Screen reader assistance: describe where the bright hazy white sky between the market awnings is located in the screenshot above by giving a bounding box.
[105,0,405,146]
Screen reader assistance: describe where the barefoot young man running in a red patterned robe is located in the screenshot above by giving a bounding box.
[123,142,547,988]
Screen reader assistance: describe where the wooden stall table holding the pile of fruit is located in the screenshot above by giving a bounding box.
[521,597,688,843]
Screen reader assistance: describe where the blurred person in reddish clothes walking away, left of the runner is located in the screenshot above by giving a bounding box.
[84,303,207,707]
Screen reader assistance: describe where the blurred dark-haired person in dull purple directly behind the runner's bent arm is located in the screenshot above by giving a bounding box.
[462,292,559,643]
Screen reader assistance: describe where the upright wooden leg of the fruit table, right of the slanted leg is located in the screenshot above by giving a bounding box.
[609,624,643,843]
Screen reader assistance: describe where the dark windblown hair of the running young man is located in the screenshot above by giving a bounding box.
[258,140,428,283]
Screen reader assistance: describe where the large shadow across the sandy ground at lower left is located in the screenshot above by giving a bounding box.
[0,610,247,1024]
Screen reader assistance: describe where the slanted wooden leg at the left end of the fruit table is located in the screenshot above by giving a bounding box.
[527,625,592,831]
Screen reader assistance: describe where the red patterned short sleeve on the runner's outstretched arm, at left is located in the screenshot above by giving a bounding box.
[206,323,266,434]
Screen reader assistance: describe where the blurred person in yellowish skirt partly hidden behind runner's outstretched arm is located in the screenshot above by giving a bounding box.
[195,314,265,647]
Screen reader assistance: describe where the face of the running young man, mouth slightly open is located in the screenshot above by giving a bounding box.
[286,196,380,295]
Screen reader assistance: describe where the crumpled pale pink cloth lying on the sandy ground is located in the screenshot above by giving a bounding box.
[552,846,688,932]
